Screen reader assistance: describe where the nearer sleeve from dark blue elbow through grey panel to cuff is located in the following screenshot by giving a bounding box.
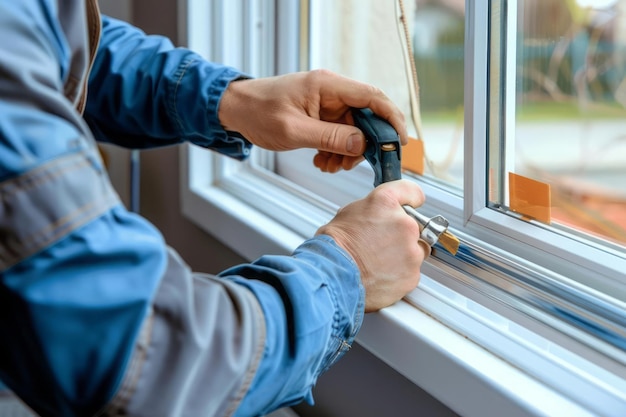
[0,194,363,416]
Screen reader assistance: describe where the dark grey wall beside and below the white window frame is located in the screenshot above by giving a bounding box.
[112,0,455,417]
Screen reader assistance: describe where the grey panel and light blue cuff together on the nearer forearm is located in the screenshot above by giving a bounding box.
[107,237,363,416]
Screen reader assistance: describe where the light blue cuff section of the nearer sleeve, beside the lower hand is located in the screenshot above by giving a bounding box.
[221,235,365,416]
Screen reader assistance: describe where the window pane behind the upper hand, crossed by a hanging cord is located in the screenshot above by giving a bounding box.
[309,0,465,193]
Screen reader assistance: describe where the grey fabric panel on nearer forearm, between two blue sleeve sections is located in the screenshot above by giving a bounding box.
[101,249,265,417]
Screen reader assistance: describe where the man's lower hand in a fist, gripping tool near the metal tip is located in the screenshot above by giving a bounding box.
[317,180,430,312]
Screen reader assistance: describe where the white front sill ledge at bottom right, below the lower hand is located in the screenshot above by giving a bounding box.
[357,296,595,417]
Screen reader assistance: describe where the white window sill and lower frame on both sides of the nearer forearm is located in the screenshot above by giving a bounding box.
[181,147,626,416]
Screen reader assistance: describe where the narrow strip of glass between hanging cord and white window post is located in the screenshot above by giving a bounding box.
[412,0,465,190]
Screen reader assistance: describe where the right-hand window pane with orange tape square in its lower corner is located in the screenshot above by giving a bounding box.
[489,0,626,245]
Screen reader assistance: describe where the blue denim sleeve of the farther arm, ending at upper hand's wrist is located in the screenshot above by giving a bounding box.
[84,16,251,159]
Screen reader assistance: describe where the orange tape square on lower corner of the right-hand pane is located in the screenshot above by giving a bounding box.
[509,172,552,224]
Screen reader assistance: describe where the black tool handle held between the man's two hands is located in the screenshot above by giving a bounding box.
[352,109,402,187]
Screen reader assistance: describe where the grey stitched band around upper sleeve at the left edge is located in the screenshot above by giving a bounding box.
[0,153,119,270]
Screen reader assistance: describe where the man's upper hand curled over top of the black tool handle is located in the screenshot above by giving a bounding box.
[219,70,408,172]
